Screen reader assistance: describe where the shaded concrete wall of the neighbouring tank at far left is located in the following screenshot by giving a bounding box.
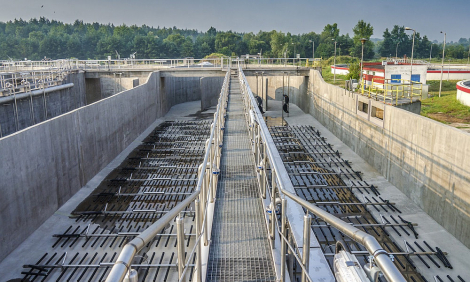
[0,72,86,137]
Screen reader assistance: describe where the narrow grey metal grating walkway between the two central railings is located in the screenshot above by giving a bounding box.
[207,72,276,281]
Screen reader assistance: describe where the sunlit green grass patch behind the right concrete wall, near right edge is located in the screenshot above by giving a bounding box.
[421,80,470,124]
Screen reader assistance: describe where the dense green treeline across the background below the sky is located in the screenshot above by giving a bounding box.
[0,17,470,60]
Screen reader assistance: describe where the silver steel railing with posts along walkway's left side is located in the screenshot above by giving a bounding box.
[106,72,230,282]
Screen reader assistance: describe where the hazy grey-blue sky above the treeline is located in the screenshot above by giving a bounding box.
[0,0,470,42]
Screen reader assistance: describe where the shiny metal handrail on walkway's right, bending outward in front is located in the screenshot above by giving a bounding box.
[239,68,406,282]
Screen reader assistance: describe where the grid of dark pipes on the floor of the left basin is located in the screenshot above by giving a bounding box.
[21,119,211,282]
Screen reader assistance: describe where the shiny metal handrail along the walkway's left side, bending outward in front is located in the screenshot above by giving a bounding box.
[106,72,230,282]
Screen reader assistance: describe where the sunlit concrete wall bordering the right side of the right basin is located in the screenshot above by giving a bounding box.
[298,70,470,247]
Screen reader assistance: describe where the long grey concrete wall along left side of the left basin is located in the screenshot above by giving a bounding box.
[0,72,224,260]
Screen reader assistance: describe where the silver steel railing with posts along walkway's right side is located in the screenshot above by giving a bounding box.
[239,68,406,282]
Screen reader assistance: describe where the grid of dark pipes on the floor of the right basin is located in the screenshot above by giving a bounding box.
[269,126,465,282]
